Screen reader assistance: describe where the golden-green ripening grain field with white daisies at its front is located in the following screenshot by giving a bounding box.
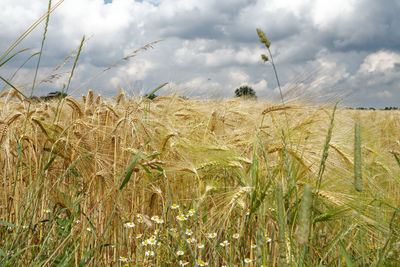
[0,90,400,266]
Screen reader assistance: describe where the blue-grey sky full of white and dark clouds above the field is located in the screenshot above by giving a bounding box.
[0,0,400,108]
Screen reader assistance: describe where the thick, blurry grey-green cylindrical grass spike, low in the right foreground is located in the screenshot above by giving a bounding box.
[298,184,312,245]
